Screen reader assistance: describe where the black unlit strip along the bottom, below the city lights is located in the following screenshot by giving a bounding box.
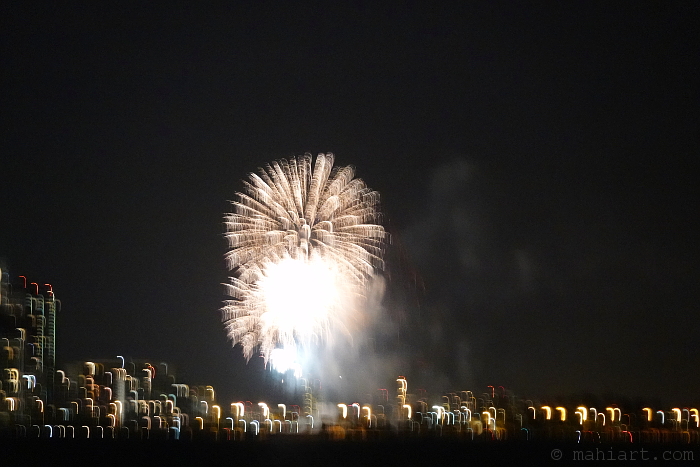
[6,437,700,467]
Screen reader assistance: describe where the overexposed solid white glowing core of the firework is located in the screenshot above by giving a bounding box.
[257,258,342,347]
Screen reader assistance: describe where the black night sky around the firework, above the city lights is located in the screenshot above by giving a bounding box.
[0,2,700,404]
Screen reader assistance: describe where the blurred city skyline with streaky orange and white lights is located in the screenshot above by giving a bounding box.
[0,271,700,446]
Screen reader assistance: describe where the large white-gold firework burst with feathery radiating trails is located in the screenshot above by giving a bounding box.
[222,153,386,370]
